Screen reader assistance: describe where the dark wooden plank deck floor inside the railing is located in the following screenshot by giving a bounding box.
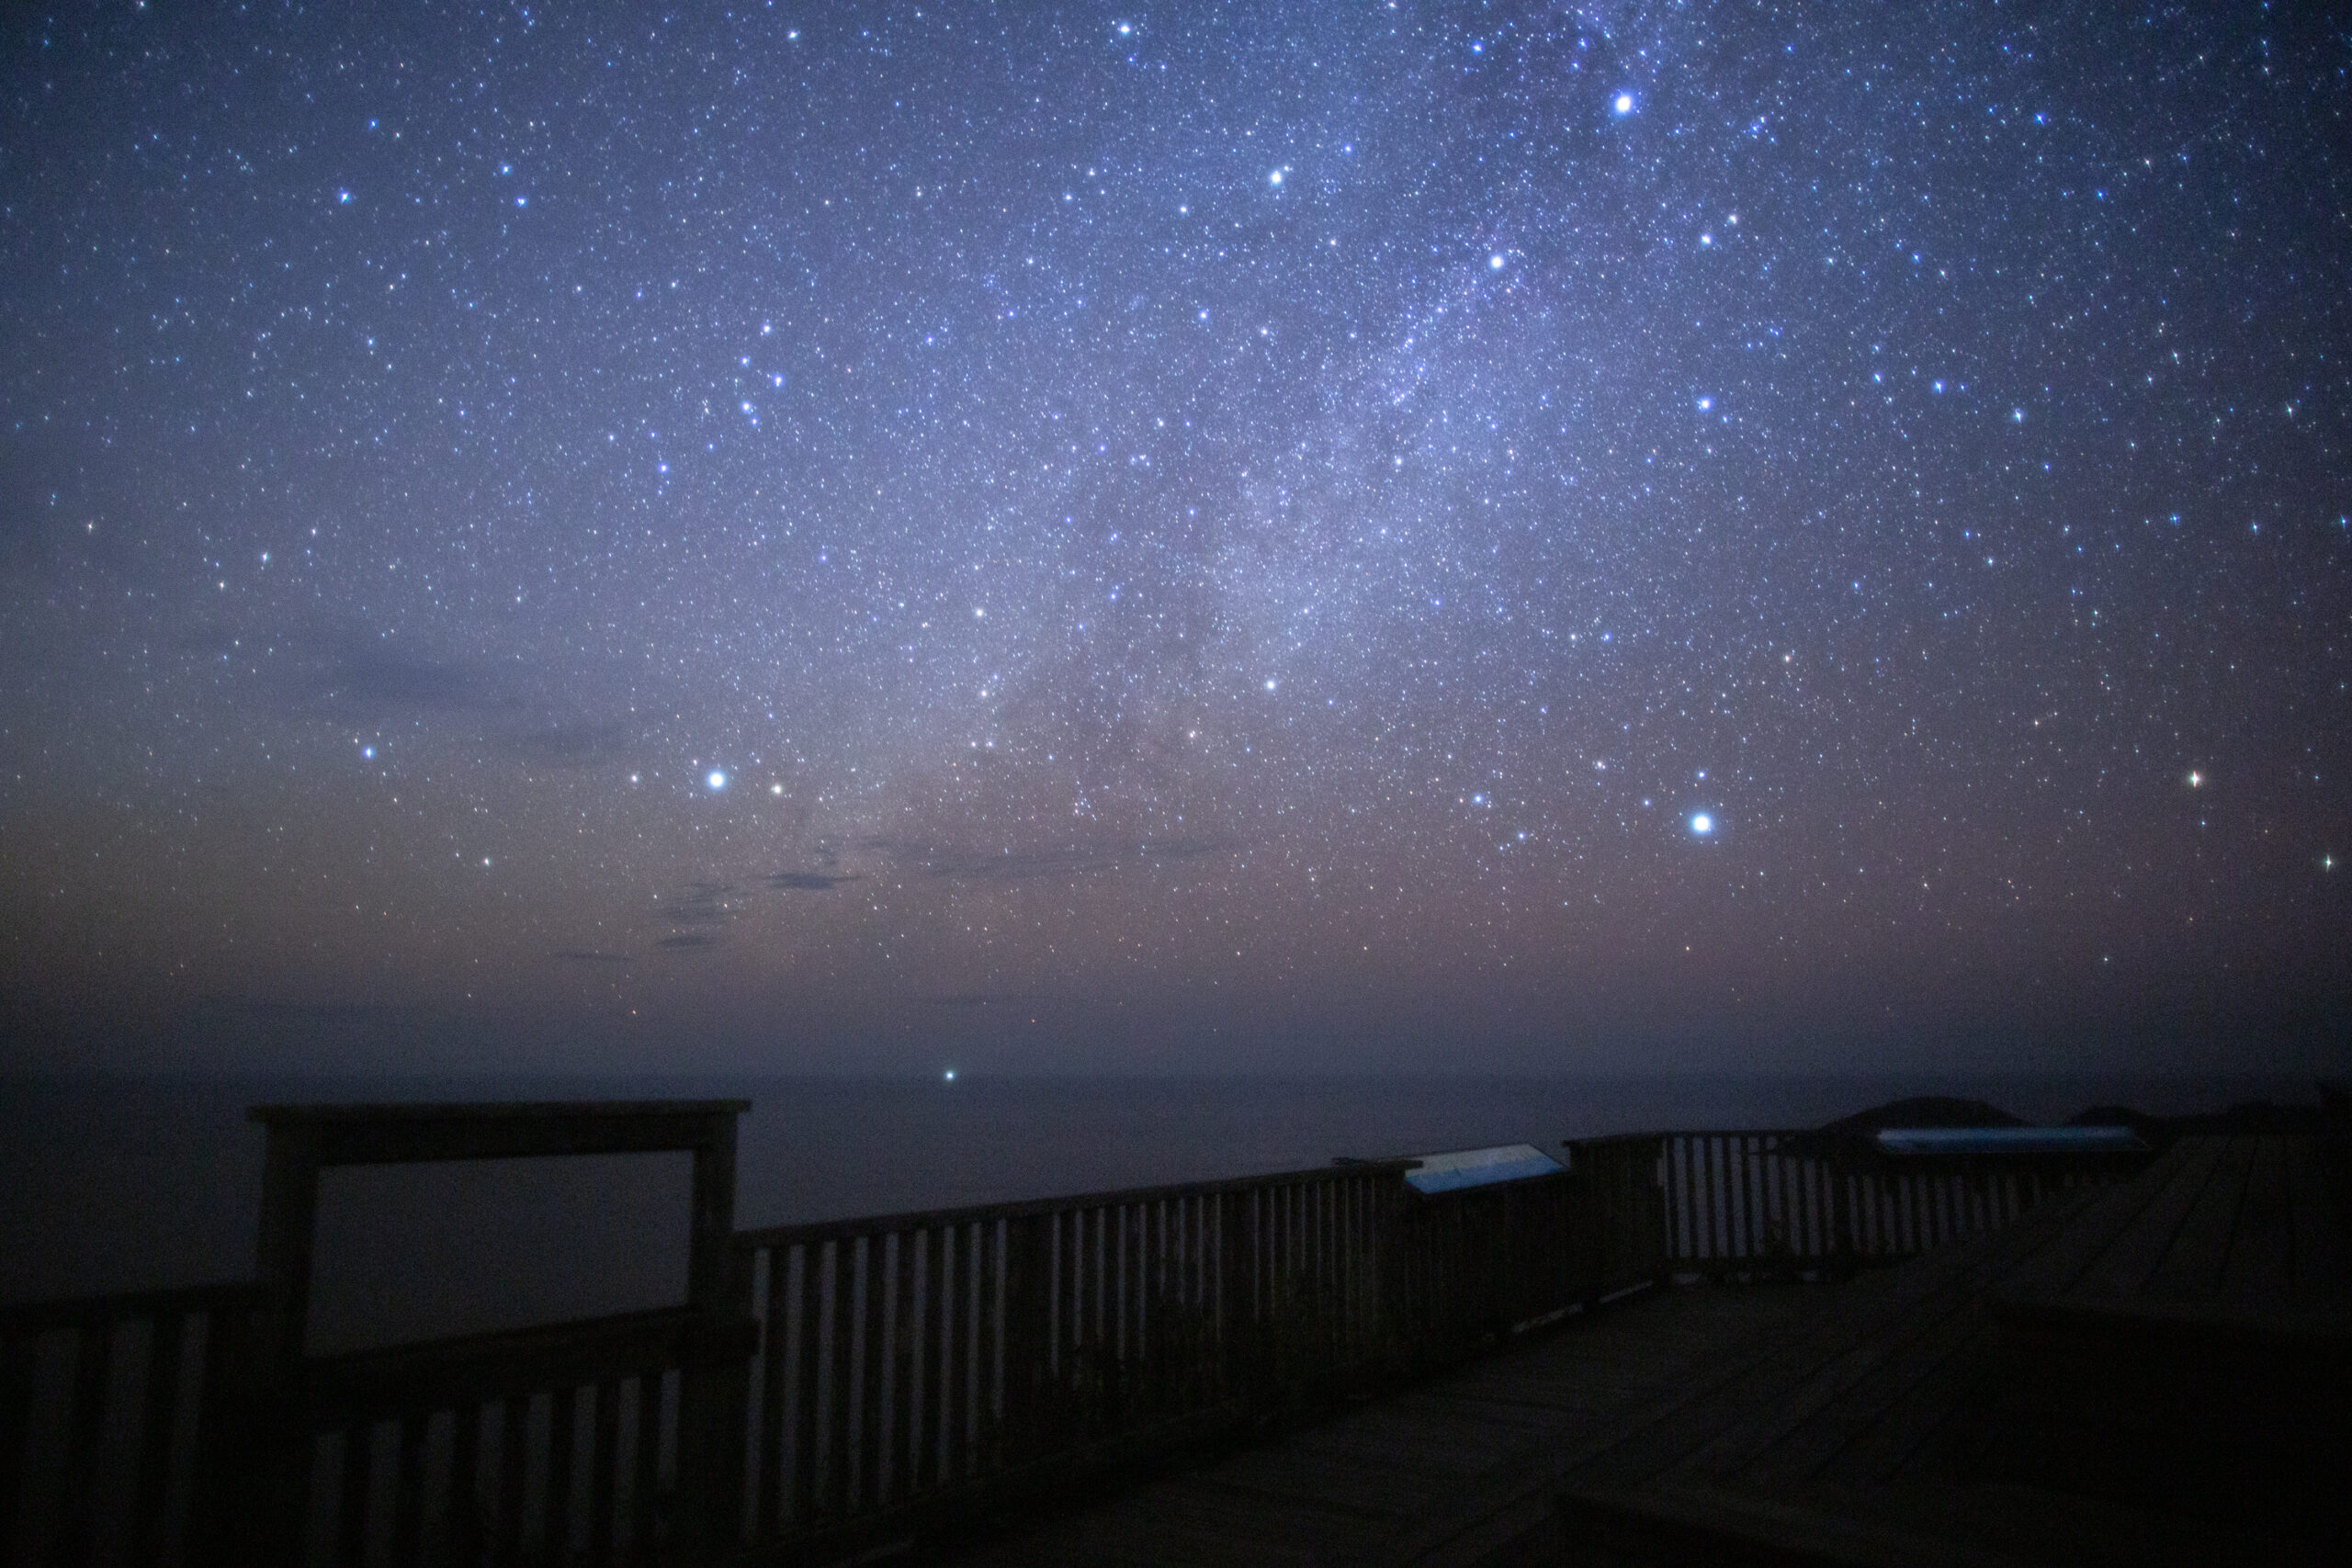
[945,1138,2352,1568]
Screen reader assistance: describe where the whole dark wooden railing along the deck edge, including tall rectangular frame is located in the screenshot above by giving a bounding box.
[0,1105,2154,1568]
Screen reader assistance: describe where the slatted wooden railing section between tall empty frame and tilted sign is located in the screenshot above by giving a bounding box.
[739,1166,1402,1544]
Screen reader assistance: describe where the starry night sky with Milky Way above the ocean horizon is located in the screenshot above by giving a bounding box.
[0,0,2352,1072]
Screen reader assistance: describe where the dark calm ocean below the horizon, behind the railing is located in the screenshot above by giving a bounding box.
[0,1077,2312,1349]
